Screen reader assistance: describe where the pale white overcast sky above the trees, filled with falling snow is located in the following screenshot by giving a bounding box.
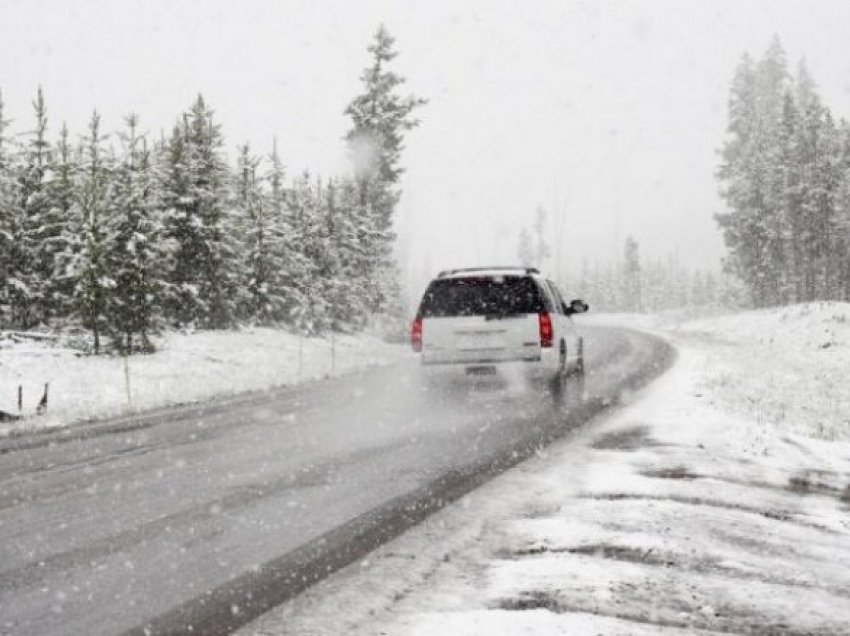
[0,0,850,294]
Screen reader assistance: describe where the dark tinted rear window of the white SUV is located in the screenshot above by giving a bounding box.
[419,276,544,318]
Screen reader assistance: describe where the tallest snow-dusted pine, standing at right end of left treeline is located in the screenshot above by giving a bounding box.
[345,25,425,312]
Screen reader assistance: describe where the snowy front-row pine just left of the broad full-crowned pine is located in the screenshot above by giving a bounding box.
[106,114,170,355]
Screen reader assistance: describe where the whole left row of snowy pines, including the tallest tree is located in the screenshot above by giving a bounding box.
[0,27,423,353]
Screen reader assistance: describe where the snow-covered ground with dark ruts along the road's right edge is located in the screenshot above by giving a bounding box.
[242,303,850,636]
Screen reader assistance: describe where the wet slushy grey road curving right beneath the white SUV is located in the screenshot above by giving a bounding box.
[0,329,671,634]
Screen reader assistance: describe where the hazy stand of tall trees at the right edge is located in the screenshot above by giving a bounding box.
[717,38,850,307]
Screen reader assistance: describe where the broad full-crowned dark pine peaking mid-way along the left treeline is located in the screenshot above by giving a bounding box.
[163,95,239,329]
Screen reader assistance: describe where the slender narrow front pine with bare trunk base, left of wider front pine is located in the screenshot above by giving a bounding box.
[73,111,115,355]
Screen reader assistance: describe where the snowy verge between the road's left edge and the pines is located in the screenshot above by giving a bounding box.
[0,328,410,435]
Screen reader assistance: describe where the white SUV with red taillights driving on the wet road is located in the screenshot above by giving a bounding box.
[411,267,588,381]
